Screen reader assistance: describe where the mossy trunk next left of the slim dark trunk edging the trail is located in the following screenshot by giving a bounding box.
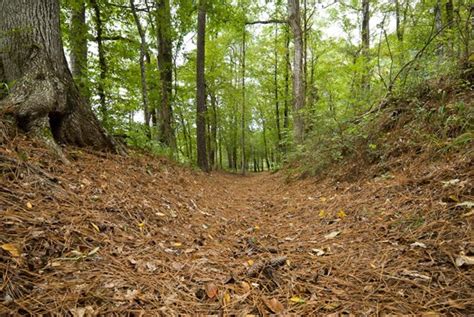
[156,0,175,148]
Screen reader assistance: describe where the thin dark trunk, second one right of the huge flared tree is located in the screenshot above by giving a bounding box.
[90,0,108,124]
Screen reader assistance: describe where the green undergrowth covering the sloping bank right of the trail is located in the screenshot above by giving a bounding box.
[290,67,474,178]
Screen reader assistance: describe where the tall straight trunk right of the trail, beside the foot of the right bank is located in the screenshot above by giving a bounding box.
[288,0,305,144]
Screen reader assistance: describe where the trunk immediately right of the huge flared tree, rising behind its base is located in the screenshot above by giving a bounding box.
[69,0,91,103]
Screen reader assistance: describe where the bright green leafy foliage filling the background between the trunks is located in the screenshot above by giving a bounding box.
[57,0,472,174]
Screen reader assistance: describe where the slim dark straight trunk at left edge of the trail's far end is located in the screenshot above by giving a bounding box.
[196,0,209,172]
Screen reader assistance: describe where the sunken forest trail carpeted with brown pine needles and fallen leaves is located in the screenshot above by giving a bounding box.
[0,141,474,316]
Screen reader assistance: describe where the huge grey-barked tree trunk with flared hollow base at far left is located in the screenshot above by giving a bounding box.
[0,0,118,151]
